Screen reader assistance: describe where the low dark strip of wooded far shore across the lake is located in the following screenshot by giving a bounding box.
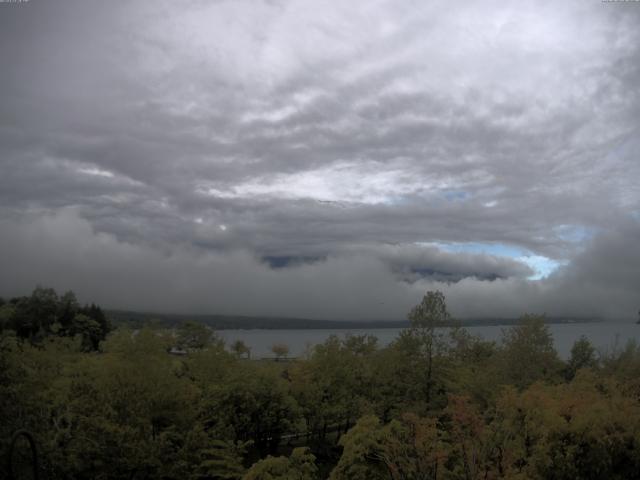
[105,310,601,330]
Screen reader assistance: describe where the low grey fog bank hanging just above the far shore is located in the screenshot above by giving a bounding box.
[0,210,640,319]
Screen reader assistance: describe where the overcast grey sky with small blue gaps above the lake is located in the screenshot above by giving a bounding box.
[0,0,640,319]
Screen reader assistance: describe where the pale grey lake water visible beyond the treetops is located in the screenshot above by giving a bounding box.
[218,322,640,358]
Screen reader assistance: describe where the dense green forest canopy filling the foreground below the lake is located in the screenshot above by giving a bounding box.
[0,288,640,480]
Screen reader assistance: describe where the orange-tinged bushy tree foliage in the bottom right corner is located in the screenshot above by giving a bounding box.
[492,374,640,479]
